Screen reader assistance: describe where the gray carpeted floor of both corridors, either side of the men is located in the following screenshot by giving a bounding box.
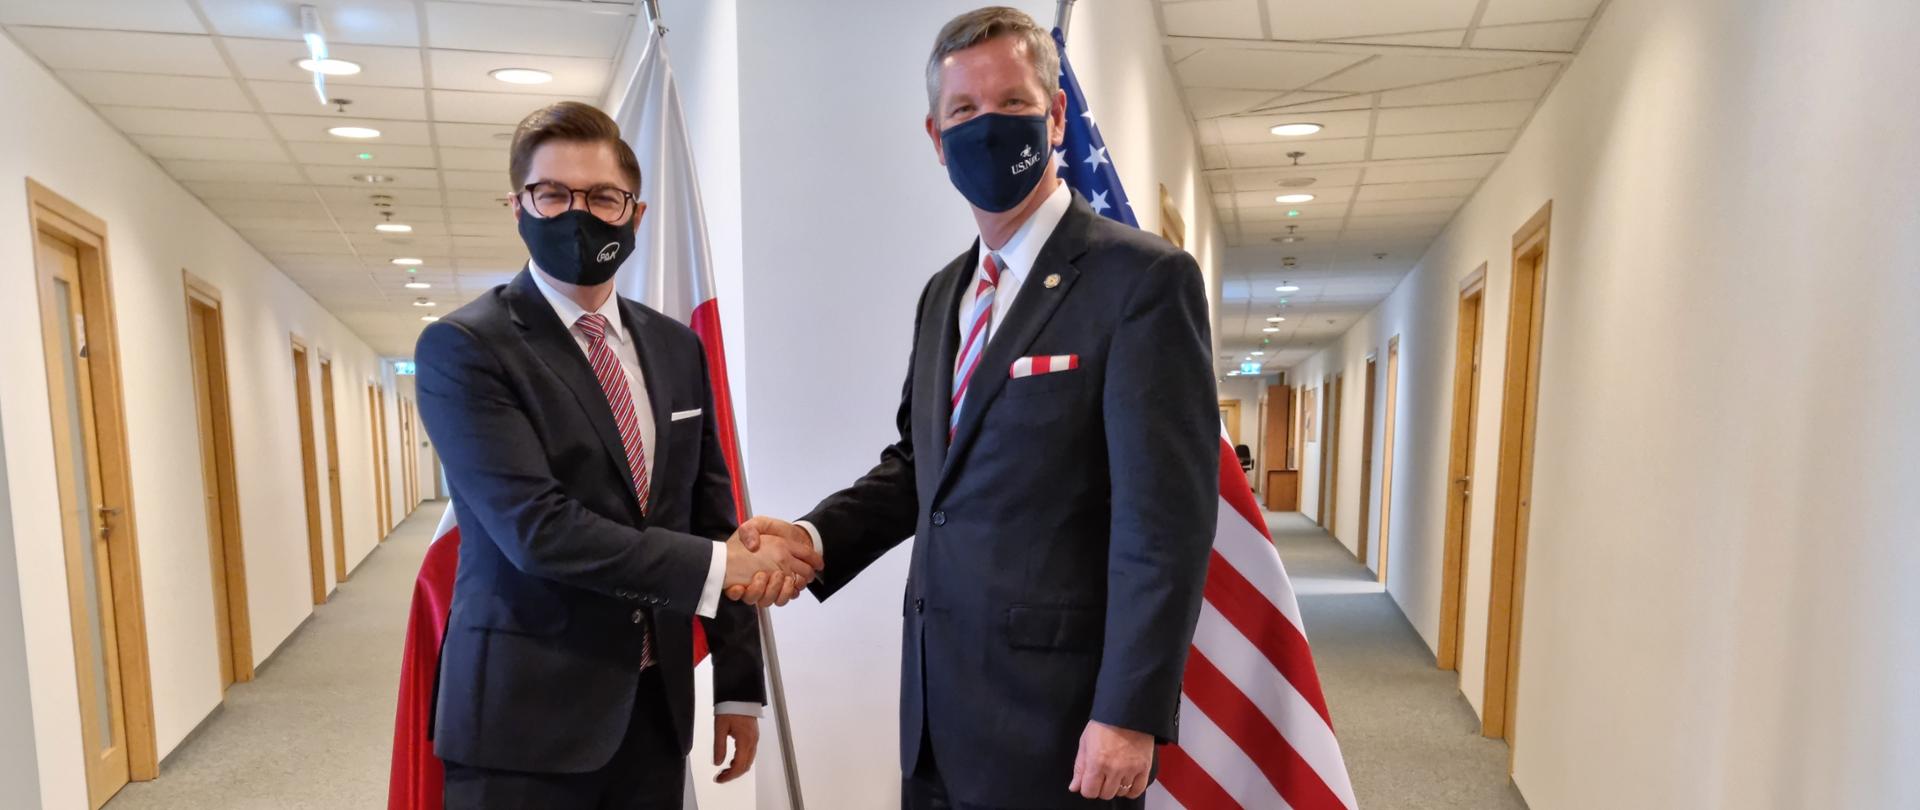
[108,503,1526,810]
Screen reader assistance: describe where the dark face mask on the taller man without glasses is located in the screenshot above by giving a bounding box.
[941,113,1052,213]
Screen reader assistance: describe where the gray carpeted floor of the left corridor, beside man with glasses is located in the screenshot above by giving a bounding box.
[106,501,445,810]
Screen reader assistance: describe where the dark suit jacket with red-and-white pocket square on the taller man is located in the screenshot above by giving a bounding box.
[806,196,1219,806]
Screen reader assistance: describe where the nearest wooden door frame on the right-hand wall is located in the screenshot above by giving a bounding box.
[1480,200,1553,744]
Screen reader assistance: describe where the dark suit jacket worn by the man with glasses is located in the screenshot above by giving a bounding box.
[415,271,766,774]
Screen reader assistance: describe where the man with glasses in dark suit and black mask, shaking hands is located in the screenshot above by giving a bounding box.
[415,102,818,810]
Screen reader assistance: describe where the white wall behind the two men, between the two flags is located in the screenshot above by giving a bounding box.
[733,0,1219,808]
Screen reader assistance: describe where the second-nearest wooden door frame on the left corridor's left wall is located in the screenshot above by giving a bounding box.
[180,271,253,693]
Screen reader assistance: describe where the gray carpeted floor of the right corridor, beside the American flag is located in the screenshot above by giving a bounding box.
[1267,512,1526,810]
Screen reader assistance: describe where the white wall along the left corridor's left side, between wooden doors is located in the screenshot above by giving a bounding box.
[0,30,392,808]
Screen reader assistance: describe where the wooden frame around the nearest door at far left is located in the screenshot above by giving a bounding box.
[27,179,159,781]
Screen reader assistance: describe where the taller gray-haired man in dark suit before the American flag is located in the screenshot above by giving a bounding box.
[733,8,1219,808]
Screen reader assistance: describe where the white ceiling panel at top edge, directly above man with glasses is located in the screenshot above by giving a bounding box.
[426,2,636,60]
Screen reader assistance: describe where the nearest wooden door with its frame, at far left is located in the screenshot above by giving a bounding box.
[27,180,157,808]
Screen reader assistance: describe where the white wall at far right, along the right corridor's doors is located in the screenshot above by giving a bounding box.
[1296,0,1920,808]
